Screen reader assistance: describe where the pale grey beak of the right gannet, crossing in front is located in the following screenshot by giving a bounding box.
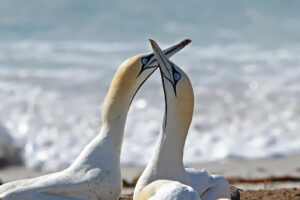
[149,39,177,85]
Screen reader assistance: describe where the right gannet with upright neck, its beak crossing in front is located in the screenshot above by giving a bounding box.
[134,40,230,200]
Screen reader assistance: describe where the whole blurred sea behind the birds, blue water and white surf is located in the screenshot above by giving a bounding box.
[0,0,300,170]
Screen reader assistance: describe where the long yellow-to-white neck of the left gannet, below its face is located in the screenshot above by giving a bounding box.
[73,68,134,168]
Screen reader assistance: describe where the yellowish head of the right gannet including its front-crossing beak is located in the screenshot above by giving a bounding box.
[150,40,194,136]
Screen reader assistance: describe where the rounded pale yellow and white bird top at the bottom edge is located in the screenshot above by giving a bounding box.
[136,180,201,200]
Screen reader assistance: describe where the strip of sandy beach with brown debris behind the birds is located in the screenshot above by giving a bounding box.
[0,154,300,199]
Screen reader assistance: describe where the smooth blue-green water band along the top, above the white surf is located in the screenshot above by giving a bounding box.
[0,0,300,45]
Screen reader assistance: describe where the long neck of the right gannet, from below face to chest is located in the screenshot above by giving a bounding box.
[134,74,194,199]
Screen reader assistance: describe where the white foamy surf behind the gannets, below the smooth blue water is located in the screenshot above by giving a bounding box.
[0,41,300,170]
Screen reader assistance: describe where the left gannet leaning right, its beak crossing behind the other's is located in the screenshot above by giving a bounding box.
[0,40,189,200]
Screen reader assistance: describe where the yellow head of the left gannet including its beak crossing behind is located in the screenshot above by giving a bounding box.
[102,40,190,122]
